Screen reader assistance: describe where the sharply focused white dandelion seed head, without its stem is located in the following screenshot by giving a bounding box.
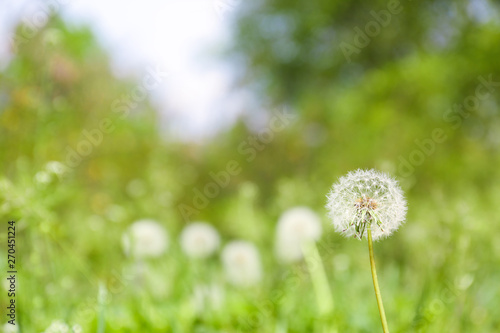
[326,169,407,240]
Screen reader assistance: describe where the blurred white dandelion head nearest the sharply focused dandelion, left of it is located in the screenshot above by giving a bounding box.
[275,207,321,263]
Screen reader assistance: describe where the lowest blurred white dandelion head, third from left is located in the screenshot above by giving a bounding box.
[222,241,262,287]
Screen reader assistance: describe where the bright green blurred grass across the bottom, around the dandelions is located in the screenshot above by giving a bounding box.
[0,165,500,333]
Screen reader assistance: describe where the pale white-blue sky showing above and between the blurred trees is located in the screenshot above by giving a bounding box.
[0,0,250,140]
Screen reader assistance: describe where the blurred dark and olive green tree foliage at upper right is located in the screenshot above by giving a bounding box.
[232,0,500,192]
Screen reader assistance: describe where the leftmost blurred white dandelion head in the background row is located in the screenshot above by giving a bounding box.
[122,219,168,258]
